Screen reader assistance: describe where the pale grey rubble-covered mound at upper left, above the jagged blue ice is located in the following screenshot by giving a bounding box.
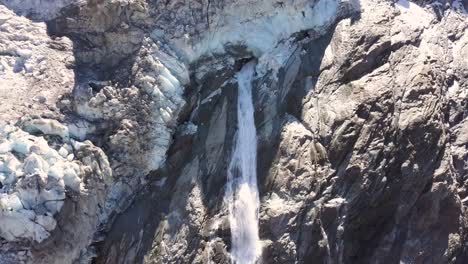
[0,5,75,121]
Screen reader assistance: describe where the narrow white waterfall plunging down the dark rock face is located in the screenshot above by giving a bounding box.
[226,62,261,264]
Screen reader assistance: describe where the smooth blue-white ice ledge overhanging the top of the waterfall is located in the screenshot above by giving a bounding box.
[152,0,341,62]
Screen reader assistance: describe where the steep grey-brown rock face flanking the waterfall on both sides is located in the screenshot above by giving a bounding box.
[95,2,467,263]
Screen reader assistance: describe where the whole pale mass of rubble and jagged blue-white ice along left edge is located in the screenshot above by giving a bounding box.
[0,6,112,263]
